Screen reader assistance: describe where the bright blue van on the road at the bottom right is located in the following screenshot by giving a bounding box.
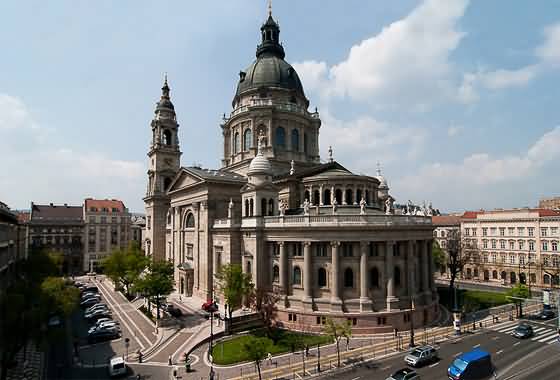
[447,348,494,380]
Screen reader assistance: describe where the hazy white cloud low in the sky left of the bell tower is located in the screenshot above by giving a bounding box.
[0,94,145,207]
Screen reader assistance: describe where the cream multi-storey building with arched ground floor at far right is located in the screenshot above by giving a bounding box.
[461,208,560,287]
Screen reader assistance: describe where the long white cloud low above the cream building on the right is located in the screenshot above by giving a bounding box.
[393,126,560,205]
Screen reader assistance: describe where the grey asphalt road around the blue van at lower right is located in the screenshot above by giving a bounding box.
[323,320,560,380]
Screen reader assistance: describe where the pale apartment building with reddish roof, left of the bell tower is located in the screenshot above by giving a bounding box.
[82,198,132,272]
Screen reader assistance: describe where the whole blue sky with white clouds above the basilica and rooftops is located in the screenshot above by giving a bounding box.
[0,0,560,212]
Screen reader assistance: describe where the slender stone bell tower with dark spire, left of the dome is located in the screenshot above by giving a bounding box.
[143,75,181,260]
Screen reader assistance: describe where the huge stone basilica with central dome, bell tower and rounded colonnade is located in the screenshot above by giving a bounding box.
[144,8,438,334]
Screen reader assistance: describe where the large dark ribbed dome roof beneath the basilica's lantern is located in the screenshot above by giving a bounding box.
[235,54,305,97]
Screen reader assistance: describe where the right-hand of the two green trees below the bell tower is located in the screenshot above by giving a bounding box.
[134,261,175,319]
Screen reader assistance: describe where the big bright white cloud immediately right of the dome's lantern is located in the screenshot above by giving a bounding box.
[294,0,467,106]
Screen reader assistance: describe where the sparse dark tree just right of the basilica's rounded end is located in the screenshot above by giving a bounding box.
[445,230,477,305]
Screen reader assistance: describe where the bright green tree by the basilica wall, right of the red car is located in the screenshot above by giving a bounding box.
[216,264,253,326]
